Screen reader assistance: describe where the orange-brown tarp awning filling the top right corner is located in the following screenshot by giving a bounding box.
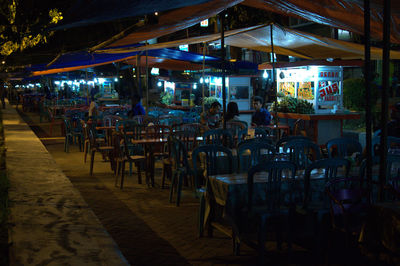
[243,0,400,43]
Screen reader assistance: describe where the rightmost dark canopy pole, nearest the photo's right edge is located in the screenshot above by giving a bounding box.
[379,0,391,201]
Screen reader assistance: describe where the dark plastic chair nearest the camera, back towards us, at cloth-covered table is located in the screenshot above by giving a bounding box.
[241,161,296,264]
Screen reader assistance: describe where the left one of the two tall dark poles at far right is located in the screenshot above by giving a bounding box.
[364,0,372,195]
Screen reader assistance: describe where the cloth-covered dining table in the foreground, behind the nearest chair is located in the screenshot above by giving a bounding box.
[200,169,340,241]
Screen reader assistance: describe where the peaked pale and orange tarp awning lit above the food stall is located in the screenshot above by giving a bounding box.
[97,25,400,59]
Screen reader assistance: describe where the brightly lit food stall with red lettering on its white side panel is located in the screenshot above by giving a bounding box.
[259,61,360,145]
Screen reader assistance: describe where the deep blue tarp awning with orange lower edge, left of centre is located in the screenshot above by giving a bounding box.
[27,49,220,76]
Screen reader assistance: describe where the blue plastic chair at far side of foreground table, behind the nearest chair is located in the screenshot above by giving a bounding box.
[237,139,275,173]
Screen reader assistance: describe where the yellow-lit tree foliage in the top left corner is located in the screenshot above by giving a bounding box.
[0,0,63,56]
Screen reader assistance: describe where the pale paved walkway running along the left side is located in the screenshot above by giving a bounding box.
[2,99,128,265]
